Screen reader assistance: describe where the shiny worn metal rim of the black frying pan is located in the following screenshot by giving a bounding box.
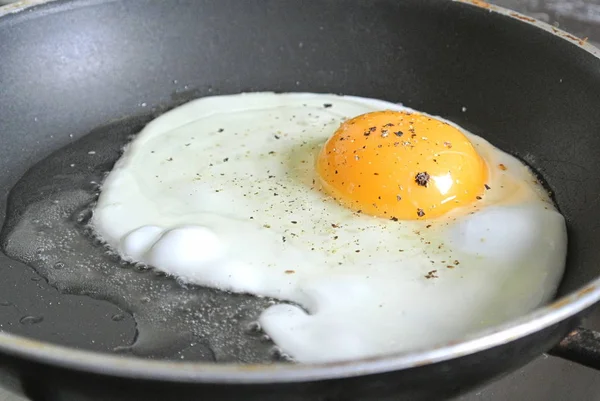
[0,0,600,384]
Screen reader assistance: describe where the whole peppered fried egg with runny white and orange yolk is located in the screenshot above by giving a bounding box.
[92,93,567,363]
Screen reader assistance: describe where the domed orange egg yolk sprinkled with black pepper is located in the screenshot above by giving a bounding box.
[317,111,488,220]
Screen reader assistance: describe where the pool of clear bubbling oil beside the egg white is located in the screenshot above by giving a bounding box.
[0,111,294,363]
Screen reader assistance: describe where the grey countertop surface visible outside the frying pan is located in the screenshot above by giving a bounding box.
[0,0,600,401]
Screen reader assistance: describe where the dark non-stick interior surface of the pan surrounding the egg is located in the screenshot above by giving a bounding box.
[0,0,600,362]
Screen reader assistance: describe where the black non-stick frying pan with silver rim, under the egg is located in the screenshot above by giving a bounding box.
[0,0,600,401]
